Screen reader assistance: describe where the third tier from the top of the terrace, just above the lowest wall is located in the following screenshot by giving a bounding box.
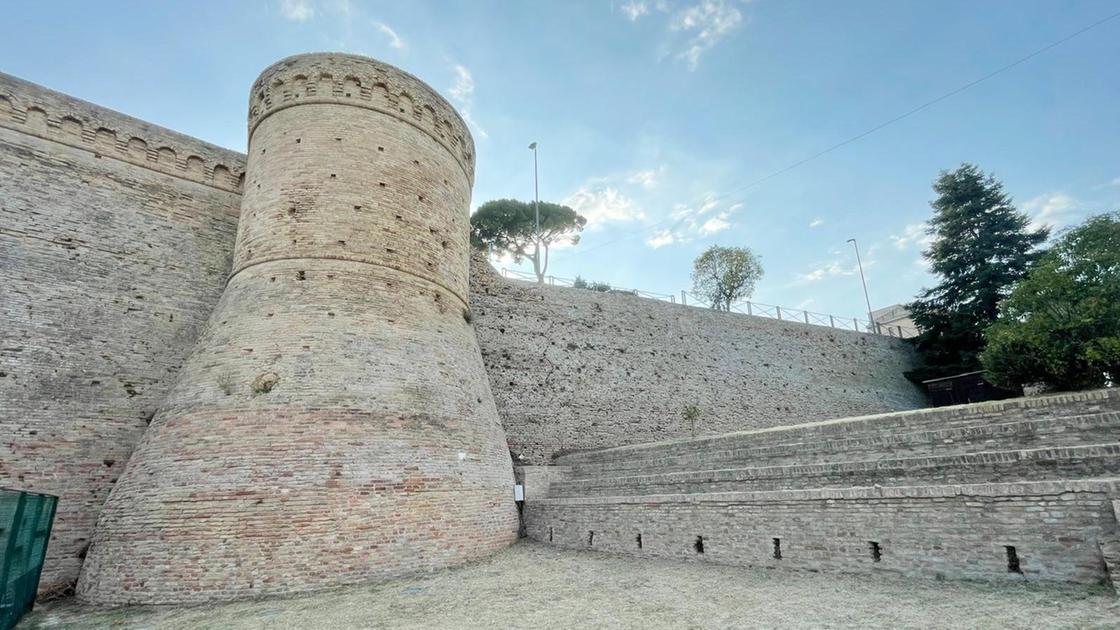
[549,443,1120,498]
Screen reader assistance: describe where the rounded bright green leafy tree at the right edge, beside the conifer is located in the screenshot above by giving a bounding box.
[980,213,1120,390]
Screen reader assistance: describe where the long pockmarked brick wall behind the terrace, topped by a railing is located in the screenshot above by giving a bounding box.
[472,256,925,464]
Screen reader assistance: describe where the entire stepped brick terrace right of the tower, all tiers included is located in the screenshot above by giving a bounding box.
[523,390,1120,585]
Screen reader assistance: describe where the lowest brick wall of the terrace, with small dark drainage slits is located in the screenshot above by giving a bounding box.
[525,481,1120,584]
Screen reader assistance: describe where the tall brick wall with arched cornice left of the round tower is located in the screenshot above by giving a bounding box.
[0,74,242,592]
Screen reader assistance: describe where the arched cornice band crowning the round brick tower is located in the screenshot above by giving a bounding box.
[249,53,475,184]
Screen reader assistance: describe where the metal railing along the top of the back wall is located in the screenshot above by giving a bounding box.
[502,267,918,339]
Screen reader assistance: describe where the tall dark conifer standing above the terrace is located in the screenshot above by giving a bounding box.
[907,164,1049,380]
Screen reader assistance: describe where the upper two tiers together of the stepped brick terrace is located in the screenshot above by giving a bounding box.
[558,389,1120,476]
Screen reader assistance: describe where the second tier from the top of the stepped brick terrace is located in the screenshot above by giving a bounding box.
[569,411,1120,479]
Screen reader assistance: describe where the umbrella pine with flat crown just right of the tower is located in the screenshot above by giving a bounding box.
[470,200,587,282]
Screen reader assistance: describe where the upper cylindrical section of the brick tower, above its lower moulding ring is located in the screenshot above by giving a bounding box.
[232,53,474,307]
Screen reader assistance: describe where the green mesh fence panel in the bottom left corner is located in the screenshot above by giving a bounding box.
[0,488,58,630]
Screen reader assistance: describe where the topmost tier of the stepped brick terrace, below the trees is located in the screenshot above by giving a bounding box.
[564,389,1120,467]
